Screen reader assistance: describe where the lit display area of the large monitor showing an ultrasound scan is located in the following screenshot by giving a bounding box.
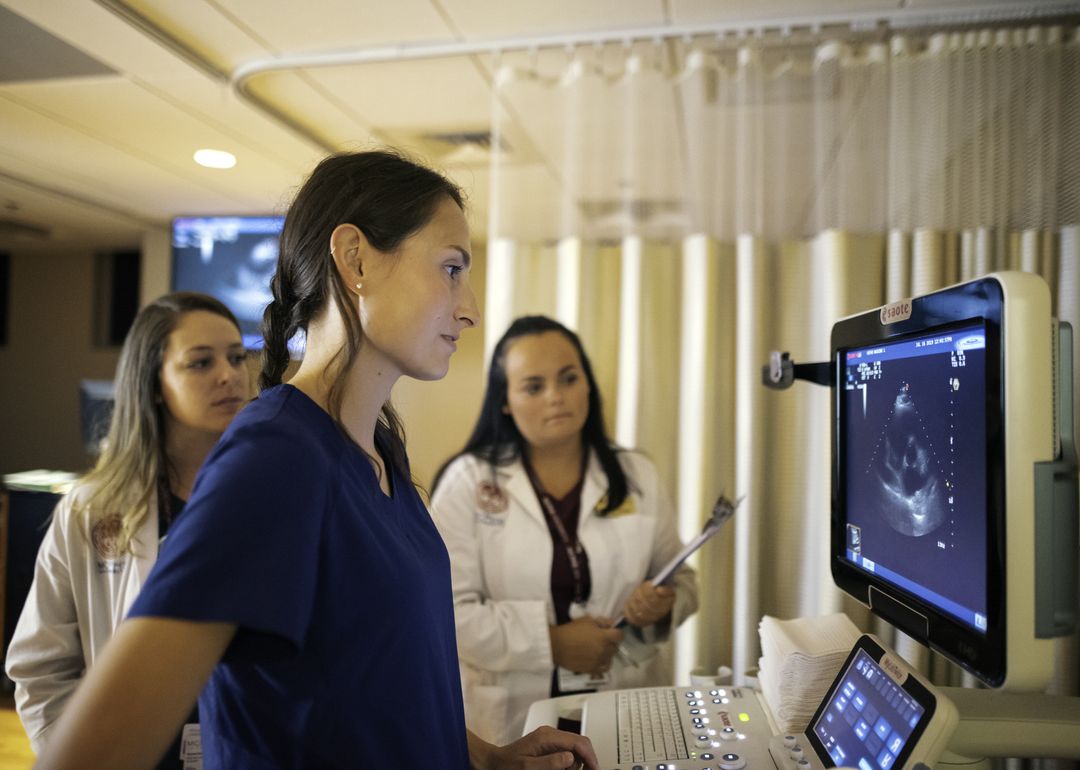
[840,324,987,631]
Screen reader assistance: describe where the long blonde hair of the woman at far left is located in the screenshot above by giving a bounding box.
[71,292,240,555]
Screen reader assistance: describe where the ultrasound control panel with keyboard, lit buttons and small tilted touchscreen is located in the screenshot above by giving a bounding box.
[581,634,958,770]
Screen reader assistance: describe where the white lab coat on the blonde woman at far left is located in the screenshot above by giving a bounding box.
[5,487,158,754]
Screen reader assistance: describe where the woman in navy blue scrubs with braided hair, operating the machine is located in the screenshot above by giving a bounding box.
[40,152,596,770]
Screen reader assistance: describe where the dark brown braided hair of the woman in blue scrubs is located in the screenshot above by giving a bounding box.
[259,150,464,477]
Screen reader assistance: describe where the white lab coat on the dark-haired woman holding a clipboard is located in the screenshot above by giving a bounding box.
[431,451,698,745]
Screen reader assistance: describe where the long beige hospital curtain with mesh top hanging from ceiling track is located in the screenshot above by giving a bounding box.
[486,19,1080,725]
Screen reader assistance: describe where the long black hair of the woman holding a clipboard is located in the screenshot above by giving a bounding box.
[431,315,630,515]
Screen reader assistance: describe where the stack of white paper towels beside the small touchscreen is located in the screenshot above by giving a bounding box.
[757,612,860,733]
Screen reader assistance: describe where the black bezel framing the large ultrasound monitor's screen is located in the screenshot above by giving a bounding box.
[831,279,1008,686]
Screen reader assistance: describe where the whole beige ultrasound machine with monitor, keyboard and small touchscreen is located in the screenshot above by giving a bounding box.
[526,272,1080,770]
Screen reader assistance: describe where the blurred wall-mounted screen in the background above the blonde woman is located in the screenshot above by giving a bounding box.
[172,211,302,356]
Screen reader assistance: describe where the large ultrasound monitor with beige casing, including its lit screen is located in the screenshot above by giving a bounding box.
[831,273,1054,689]
